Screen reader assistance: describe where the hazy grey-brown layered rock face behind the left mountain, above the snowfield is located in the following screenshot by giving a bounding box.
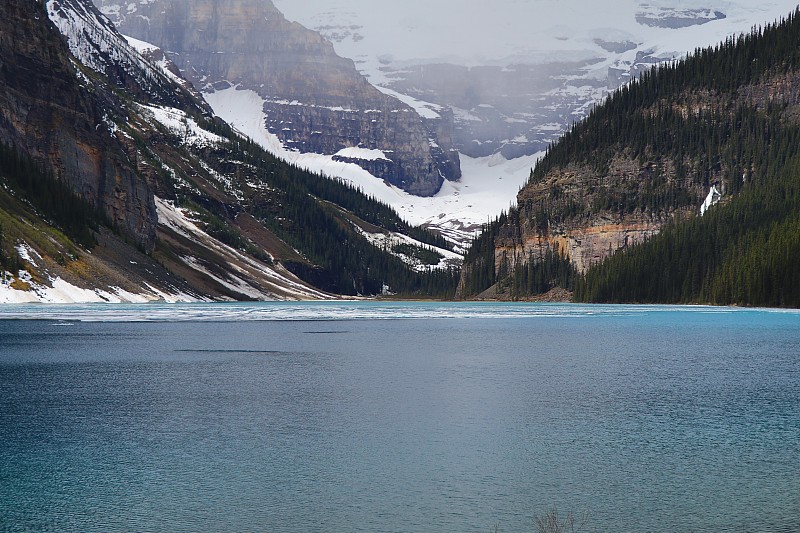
[96,0,461,196]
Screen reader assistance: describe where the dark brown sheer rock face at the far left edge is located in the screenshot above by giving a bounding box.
[0,0,157,250]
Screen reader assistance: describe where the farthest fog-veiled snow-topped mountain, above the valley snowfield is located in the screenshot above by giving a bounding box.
[274,0,796,160]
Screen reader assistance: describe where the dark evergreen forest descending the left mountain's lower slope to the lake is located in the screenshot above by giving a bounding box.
[190,138,460,298]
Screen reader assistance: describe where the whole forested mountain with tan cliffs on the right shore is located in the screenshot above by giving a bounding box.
[461,7,800,306]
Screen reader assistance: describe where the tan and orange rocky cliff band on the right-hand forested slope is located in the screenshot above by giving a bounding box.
[495,154,704,272]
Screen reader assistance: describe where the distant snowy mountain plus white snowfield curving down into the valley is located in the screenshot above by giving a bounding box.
[90,0,794,247]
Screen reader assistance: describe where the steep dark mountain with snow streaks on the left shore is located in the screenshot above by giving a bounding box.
[0,0,459,301]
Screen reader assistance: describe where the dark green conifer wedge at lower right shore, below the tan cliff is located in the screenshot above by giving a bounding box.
[575,154,800,307]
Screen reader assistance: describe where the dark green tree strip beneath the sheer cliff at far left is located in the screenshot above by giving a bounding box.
[0,143,106,248]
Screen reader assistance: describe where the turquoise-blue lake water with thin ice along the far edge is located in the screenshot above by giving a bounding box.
[0,302,800,532]
